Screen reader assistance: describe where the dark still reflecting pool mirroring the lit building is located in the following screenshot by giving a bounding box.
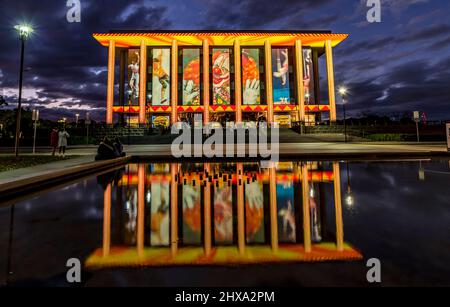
[0,160,450,286]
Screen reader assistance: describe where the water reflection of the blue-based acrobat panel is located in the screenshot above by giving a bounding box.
[277,181,296,243]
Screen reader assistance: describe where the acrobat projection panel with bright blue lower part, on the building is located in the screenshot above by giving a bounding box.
[272,48,292,104]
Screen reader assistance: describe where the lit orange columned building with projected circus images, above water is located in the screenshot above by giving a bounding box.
[93,31,348,127]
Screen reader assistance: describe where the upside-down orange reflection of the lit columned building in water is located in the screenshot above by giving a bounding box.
[87,162,362,266]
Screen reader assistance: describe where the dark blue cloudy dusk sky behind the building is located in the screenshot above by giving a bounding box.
[0,0,450,119]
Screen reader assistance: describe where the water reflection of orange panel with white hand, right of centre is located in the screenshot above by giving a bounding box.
[245,181,265,243]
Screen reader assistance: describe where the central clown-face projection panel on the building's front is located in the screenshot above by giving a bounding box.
[212,48,231,105]
